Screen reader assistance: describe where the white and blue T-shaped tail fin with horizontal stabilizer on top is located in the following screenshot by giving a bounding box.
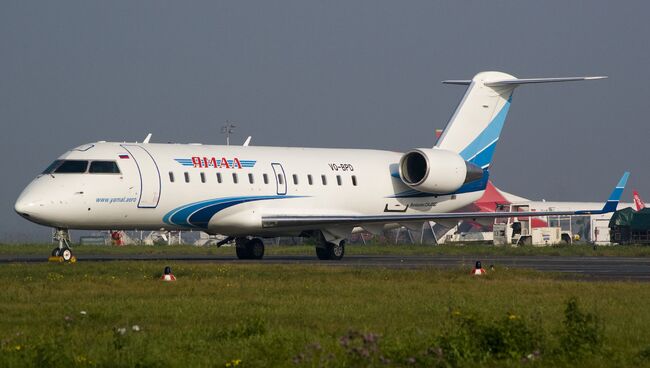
[436,72,607,170]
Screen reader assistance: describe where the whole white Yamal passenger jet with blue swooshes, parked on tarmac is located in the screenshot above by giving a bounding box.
[15,72,628,260]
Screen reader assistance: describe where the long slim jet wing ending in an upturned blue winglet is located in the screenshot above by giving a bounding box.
[262,172,630,228]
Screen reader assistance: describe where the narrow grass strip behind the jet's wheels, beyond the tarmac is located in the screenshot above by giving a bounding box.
[0,242,650,257]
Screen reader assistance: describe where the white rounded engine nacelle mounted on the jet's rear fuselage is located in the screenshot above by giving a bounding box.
[399,148,483,194]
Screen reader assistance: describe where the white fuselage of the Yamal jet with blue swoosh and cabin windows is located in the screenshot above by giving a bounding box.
[16,142,480,236]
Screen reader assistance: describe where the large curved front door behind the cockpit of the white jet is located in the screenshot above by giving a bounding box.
[122,144,161,208]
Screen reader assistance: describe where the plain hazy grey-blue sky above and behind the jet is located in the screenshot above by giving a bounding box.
[0,0,650,241]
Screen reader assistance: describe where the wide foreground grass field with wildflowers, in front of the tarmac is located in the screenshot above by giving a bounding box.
[0,262,650,367]
